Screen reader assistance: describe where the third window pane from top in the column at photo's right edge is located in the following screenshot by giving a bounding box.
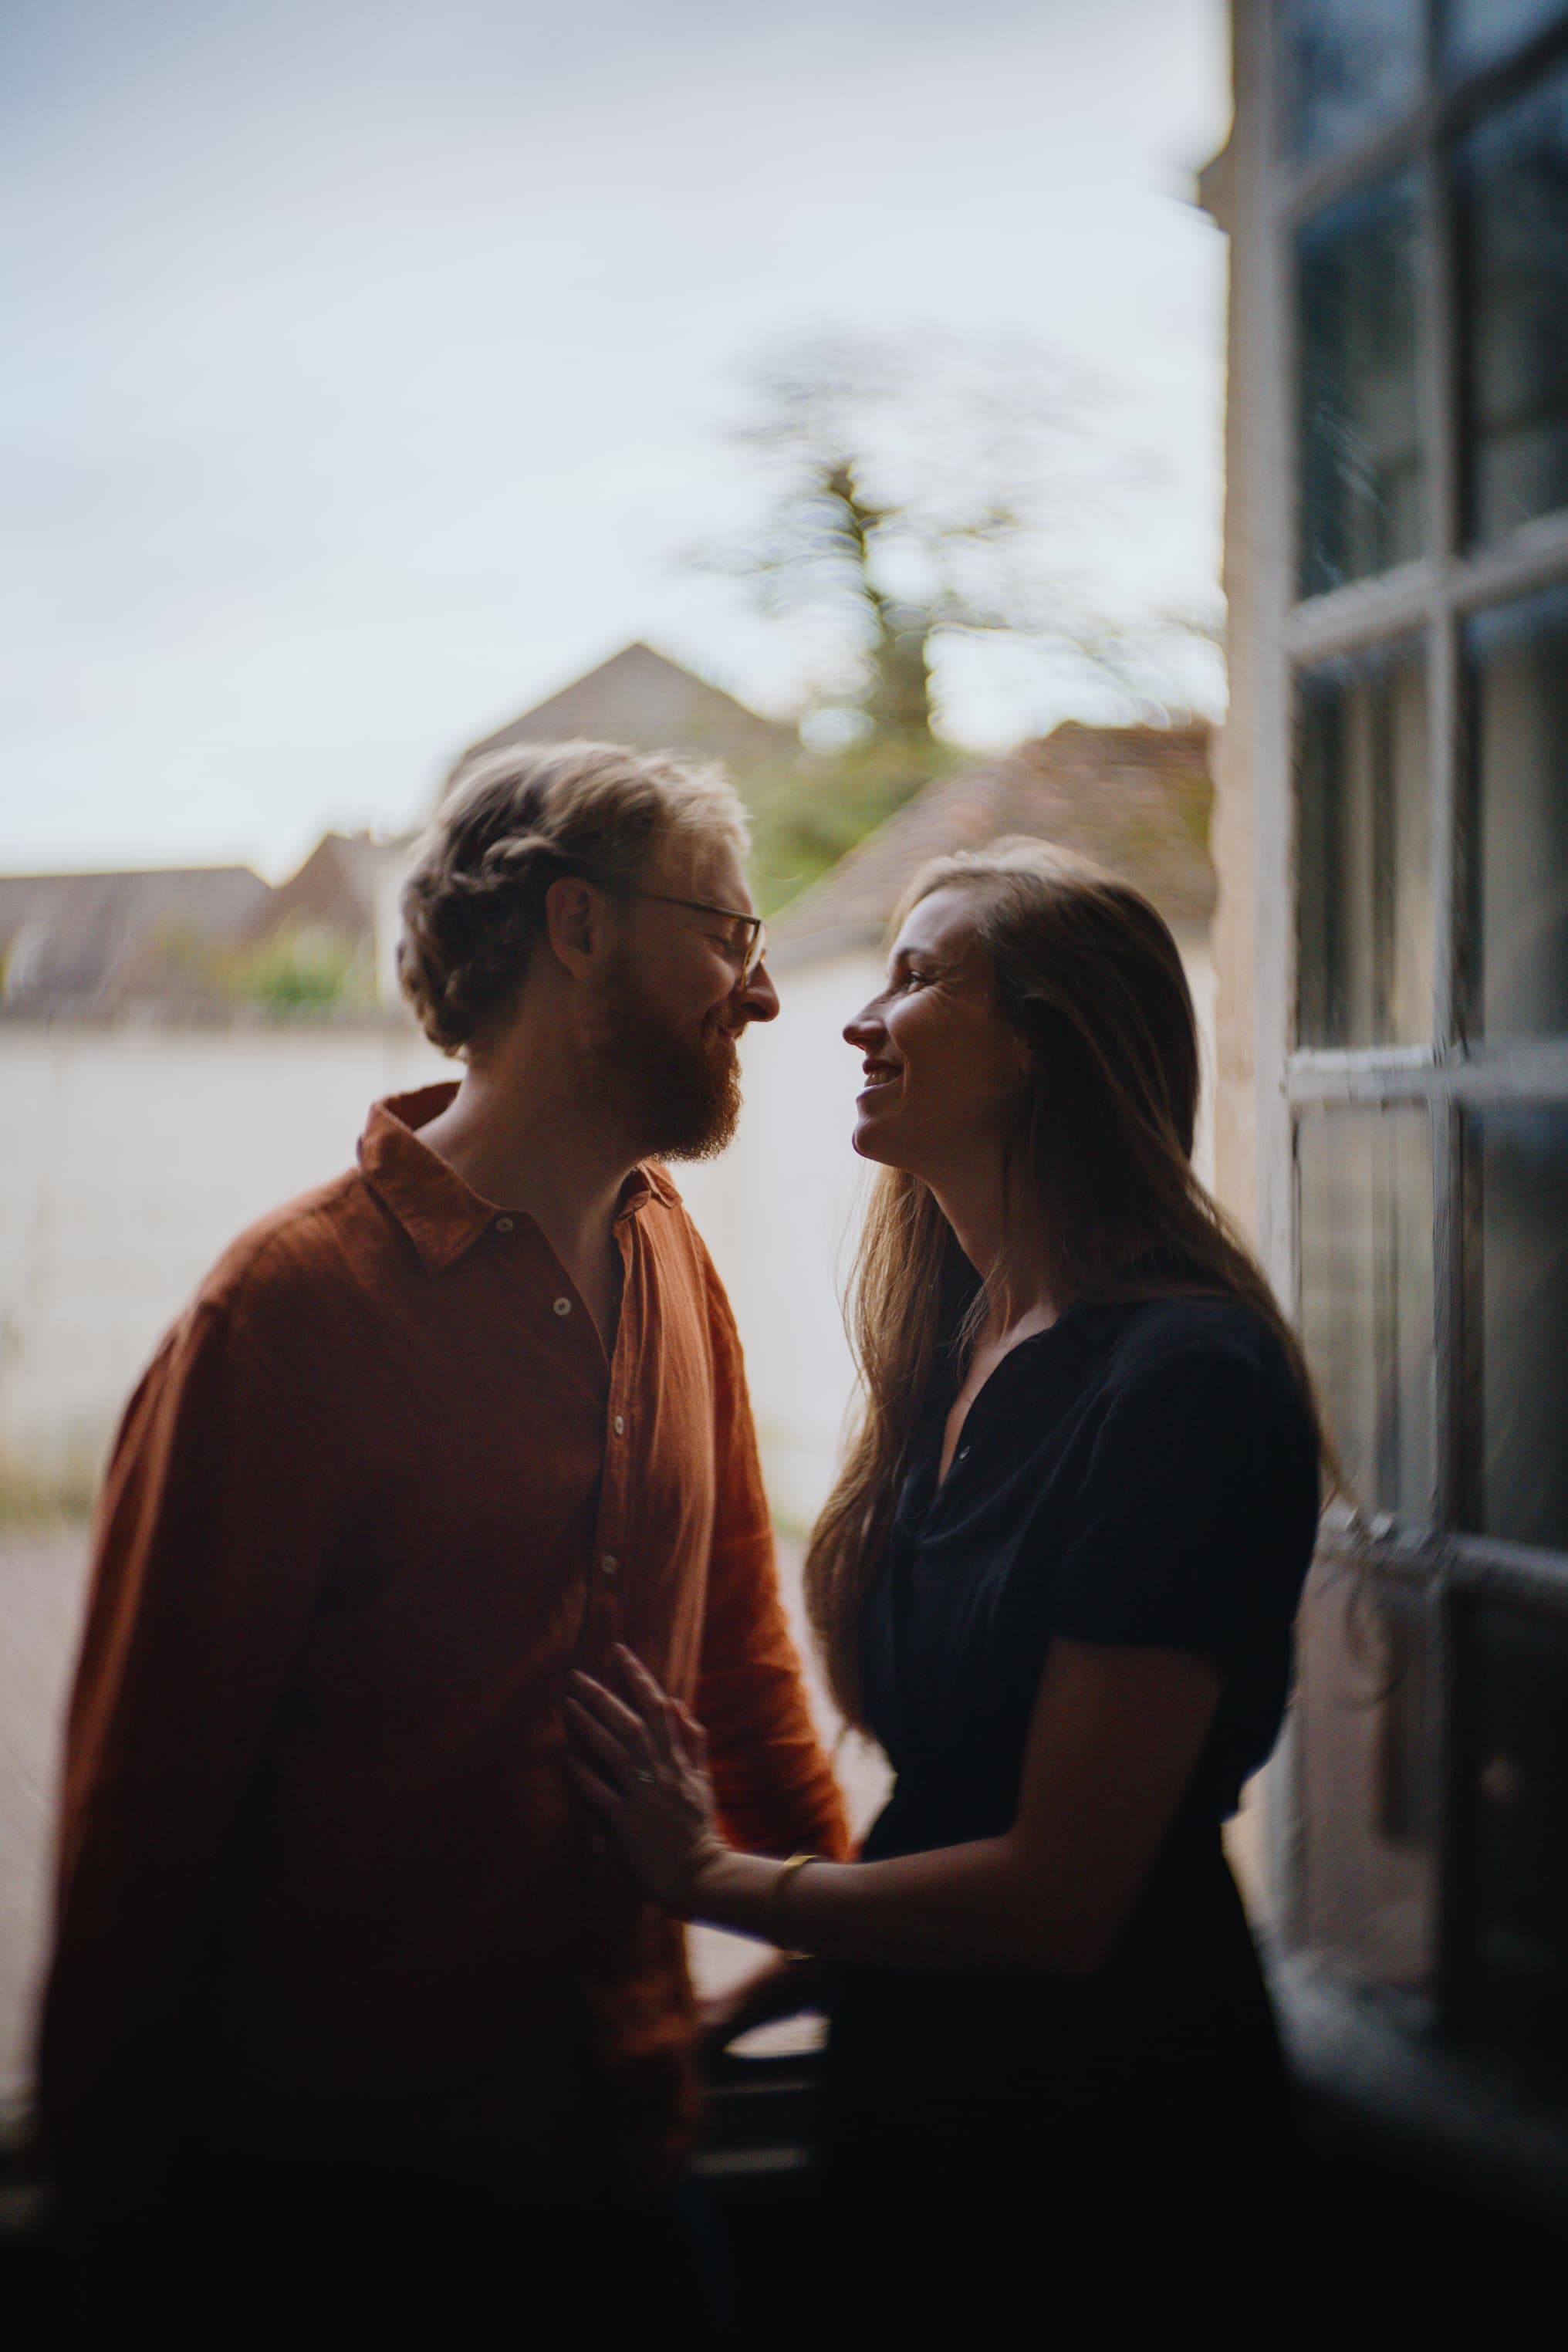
[1465,588,1568,1037]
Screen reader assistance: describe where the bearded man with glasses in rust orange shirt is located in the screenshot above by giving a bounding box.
[40,743,844,2345]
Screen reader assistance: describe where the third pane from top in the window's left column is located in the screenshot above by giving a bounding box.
[1296,644,1431,1046]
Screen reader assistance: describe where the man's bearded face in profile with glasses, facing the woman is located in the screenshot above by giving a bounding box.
[590,837,778,1160]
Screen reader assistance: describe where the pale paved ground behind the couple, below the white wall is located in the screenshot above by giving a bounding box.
[0,1526,887,2093]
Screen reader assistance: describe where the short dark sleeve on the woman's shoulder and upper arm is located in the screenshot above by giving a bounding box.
[1049,1350,1309,1672]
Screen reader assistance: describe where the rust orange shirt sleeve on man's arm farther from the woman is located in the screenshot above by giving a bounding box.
[40,1303,343,2195]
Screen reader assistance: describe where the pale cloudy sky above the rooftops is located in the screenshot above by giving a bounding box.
[0,0,1229,877]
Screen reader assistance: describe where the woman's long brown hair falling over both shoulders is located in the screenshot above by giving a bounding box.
[806,840,1335,1724]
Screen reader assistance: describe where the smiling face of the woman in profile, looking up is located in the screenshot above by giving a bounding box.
[844,887,1029,1183]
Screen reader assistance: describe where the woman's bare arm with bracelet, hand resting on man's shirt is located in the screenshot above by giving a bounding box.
[573,1642,1220,1975]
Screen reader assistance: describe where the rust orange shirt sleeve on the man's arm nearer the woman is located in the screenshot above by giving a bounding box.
[694,1268,849,1858]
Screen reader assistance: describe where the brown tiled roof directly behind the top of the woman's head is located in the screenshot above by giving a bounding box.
[769,720,1215,960]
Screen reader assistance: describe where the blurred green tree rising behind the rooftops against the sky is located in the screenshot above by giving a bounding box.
[689,339,1213,903]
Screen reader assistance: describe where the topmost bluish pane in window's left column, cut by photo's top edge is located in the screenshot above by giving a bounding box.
[1286,0,1424,160]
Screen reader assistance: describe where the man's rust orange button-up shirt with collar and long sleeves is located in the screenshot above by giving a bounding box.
[42,1086,847,2197]
